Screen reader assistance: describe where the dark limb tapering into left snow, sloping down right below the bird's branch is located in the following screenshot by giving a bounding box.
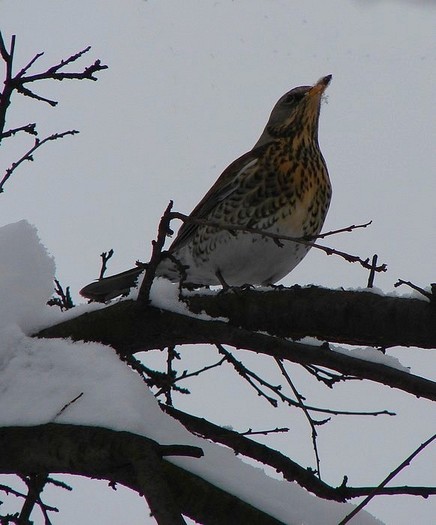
[35,301,436,400]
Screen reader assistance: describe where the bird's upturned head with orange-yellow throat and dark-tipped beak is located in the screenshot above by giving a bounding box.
[255,75,332,147]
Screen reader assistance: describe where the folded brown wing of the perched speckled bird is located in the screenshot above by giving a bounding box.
[169,144,269,252]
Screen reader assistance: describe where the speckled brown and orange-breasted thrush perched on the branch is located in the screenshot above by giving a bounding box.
[80,75,332,302]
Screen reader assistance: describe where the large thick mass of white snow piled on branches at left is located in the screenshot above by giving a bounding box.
[0,221,381,525]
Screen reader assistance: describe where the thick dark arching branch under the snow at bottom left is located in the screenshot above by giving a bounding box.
[0,424,281,525]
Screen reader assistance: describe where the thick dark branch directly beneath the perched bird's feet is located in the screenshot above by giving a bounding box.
[186,286,436,348]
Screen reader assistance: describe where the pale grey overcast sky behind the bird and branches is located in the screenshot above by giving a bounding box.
[0,0,436,525]
